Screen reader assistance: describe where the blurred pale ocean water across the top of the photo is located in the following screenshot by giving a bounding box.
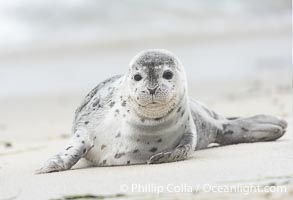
[0,0,291,50]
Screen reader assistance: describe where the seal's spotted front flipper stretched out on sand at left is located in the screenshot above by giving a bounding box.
[36,135,90,174]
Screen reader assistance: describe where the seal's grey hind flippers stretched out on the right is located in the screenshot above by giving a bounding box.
[215,115,287,145]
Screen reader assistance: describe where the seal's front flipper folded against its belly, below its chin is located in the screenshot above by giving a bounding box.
[148,133,194,164]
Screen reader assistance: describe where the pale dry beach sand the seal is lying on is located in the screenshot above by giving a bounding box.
[0,72,293,200]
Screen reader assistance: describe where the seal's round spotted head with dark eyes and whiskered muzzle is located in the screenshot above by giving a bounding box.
[127,50,186,119]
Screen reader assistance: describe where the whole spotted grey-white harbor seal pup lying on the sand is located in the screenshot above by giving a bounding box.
[38,50,287,173]
